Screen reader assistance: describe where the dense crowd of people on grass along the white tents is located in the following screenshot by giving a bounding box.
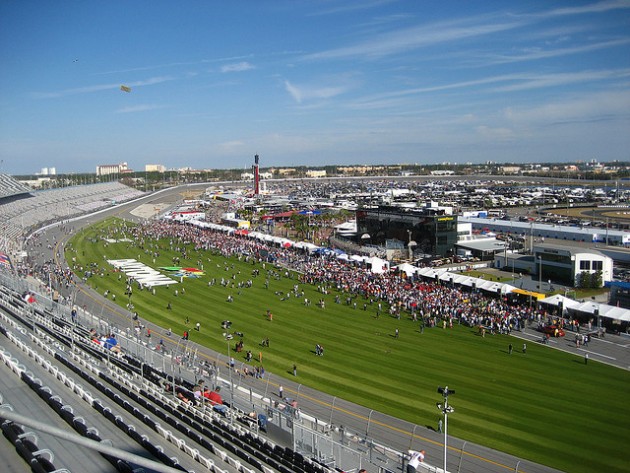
[116,221,554,333]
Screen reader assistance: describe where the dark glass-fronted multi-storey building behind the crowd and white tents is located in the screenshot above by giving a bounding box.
[356,207,457,256]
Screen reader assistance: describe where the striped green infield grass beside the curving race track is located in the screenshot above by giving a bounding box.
[66,219,630,473]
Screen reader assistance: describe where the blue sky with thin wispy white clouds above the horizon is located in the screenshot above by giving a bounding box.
[0,0,630,174]
